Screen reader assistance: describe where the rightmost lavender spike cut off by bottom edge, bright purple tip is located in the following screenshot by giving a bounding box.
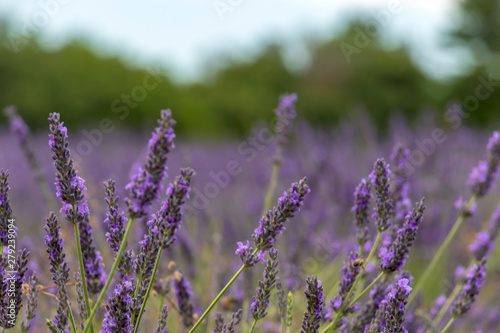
[384,279,411,333]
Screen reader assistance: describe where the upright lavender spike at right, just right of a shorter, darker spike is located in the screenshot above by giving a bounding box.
[370,158,394,231]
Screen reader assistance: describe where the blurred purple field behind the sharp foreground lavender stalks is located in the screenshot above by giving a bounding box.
[0,102,500,333]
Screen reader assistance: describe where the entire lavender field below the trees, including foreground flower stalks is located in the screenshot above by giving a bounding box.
[0,94,500,333]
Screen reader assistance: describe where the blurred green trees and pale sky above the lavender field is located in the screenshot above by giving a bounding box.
[0,0,500,139]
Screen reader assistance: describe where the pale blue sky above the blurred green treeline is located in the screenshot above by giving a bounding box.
[0,0,462,81]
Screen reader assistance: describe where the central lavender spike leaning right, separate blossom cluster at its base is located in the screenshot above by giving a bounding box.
[240,177,311,266]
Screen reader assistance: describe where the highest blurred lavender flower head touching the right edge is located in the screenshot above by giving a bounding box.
[468,132,500,197]
